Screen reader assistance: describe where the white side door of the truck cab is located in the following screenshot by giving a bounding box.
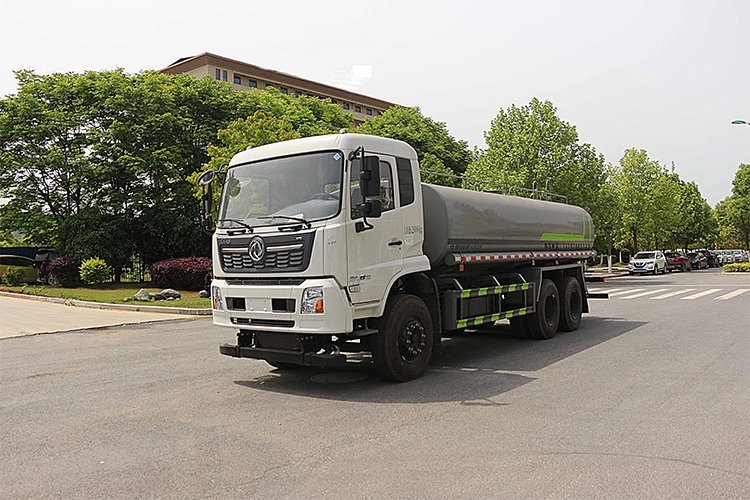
[346,155,403,304]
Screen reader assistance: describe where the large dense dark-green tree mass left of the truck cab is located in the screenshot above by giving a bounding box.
[0,71,248,277]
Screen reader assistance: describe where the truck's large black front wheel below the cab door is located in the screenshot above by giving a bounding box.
[371,294,434,382]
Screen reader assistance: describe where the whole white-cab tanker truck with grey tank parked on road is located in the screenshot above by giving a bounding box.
[199,133,594,381]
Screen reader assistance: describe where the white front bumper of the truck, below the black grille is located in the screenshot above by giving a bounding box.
[212,278,353,335]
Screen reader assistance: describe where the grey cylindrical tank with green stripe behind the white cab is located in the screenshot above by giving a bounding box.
[422,184,594,266]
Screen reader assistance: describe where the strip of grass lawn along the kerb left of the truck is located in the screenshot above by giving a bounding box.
[0,283,211,308]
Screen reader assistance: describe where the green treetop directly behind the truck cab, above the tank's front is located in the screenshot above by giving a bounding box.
[356,106,472,183]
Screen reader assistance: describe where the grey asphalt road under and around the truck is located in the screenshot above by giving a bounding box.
[0,270,750,498]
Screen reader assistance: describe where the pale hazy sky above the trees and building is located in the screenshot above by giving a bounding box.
[0,0,750,205]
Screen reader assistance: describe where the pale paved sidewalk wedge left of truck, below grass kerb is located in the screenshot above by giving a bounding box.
[0,296,200,339]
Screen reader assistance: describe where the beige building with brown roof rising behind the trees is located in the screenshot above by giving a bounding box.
[161,52,395,125]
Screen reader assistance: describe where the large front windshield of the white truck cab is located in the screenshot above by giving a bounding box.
[219,151,344,227]
